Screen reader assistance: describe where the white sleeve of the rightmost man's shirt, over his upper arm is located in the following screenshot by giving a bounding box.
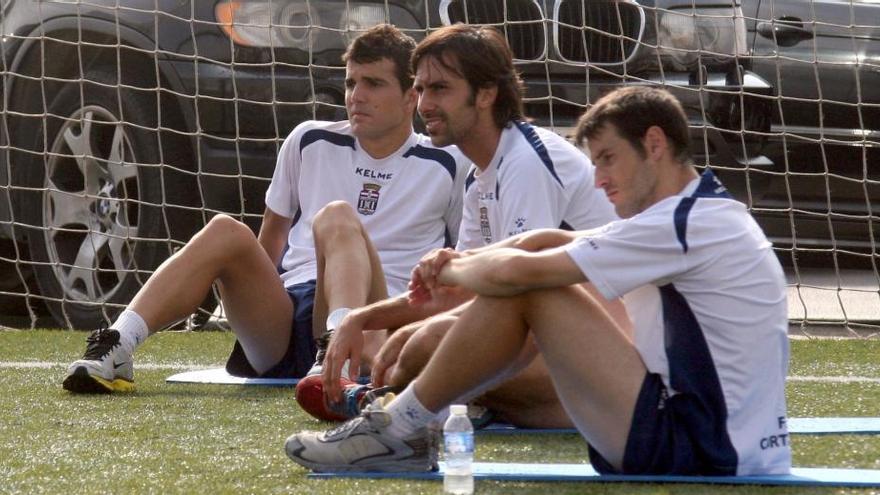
[566,214,686,299]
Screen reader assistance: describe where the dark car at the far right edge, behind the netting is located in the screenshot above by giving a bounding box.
[742,0,880,267]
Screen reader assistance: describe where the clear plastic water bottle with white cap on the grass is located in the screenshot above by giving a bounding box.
[443,404,474,495]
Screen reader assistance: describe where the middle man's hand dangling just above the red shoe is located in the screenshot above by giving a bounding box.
[321,310,364,403]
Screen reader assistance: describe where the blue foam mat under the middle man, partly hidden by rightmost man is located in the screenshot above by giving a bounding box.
[476,418,880,435]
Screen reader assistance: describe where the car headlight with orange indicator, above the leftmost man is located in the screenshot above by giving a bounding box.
[214,0,418,51]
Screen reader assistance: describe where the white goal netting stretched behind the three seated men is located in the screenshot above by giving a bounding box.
[0,0,880,336]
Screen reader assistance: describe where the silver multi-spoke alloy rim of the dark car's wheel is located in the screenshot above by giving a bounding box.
[42,105,141,303]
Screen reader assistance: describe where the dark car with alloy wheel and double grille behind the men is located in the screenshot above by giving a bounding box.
[0,0,771,327]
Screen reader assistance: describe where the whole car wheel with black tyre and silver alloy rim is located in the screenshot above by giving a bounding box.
[18,70,170,328]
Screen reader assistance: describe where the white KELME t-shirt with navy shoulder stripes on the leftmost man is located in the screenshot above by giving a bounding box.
[266,121,467,295]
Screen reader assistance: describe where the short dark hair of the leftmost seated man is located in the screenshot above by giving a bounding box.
[342,24,416,91]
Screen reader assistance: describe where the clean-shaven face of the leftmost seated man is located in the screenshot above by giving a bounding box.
[345,58,416,140]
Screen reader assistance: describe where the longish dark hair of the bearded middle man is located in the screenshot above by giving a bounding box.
[412,23,525,128]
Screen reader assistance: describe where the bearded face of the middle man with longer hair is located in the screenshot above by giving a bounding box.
[413,57,477,146]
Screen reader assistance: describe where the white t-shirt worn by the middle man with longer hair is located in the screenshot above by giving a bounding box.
[456,122,617,250]
